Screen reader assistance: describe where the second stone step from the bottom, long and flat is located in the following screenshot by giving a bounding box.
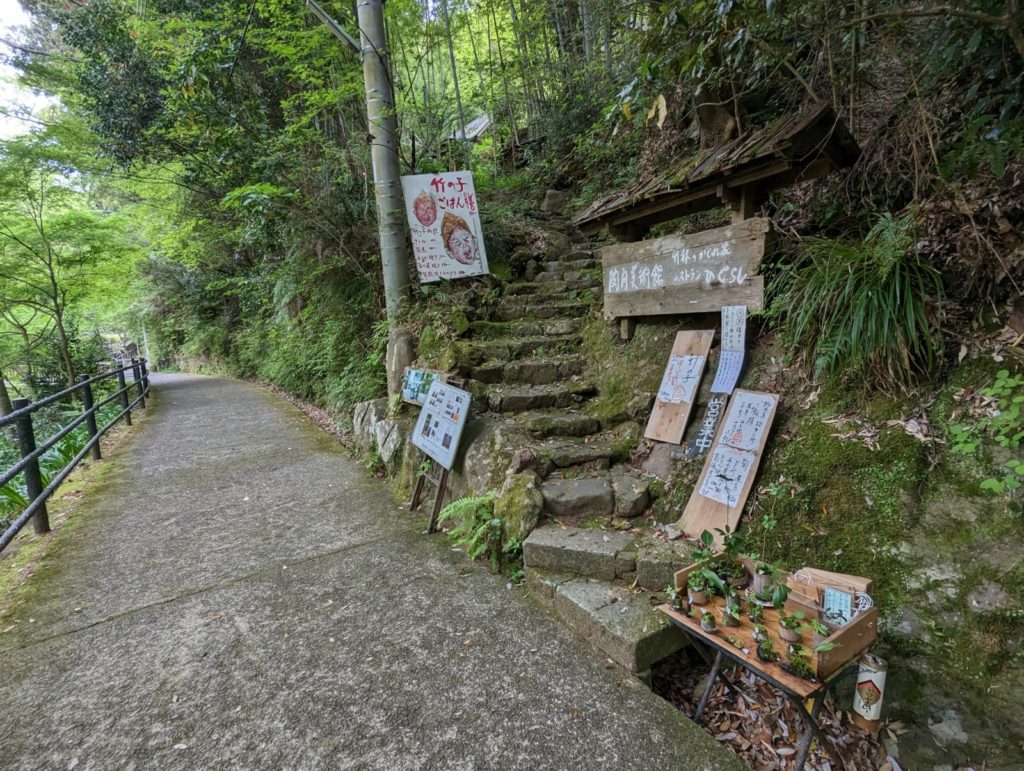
[522,524,693,592]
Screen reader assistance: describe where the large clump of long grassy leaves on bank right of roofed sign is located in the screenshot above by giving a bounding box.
[769,214,942,390]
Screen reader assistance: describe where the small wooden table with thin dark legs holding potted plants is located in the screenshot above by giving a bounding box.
[657,597,857,771]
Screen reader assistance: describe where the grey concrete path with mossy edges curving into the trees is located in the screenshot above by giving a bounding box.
[0,376,742,769]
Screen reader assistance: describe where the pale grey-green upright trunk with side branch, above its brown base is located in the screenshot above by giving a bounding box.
[306,0,409,326]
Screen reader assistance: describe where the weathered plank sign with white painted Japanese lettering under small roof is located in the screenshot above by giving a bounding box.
[601,217,771,319]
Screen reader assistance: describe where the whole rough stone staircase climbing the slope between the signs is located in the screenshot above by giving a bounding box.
[446,219,704,676]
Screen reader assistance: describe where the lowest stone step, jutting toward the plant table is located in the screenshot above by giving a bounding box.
[526,568,687,675]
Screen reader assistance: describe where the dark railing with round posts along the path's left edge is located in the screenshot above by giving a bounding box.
[0,358,150,552]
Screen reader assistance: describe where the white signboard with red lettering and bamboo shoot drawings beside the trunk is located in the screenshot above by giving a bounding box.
[401,171,487,284]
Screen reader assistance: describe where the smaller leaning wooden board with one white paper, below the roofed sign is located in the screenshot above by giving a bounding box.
[644,330,715,444]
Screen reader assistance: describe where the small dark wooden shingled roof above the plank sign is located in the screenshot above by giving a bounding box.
[573,101,860,241]
